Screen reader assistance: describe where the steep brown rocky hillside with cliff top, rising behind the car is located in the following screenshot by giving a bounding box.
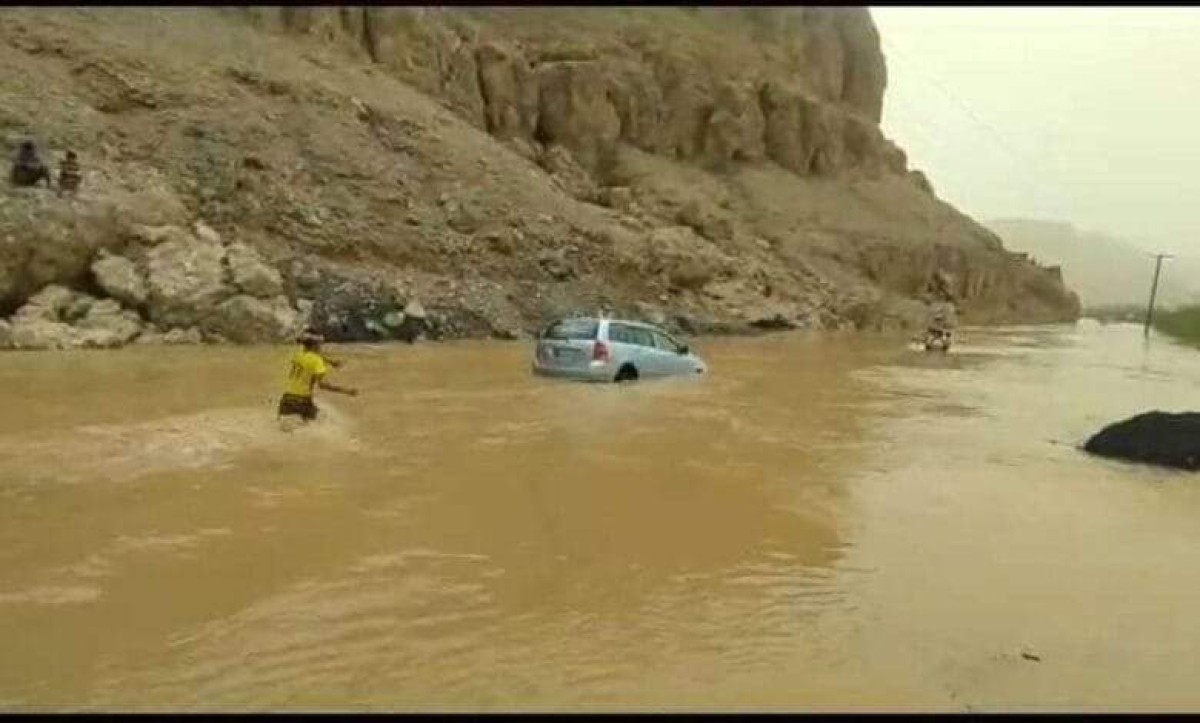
[0,7,1079,347]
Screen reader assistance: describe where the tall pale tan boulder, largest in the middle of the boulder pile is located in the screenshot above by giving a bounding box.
[146,232,233,328]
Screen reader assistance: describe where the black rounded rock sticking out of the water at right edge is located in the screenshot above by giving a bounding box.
[1084,412,1200,470]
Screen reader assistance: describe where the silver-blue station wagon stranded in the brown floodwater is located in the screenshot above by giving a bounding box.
[533,317,708,382]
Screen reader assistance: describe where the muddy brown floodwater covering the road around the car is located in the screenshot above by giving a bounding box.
[0,322,1200,711]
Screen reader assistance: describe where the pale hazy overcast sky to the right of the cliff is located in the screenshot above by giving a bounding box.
[871,7,1200,256]
